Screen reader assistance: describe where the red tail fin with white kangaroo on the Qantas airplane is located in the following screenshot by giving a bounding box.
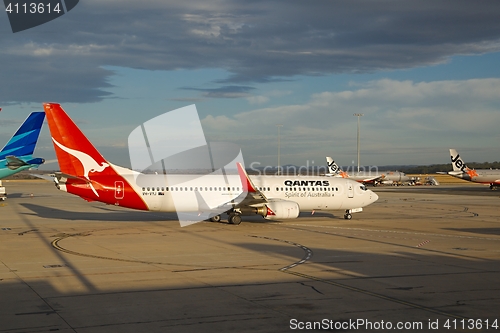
[43,103,111,178]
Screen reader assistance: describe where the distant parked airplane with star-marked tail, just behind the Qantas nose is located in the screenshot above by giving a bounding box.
[325,156,410,186]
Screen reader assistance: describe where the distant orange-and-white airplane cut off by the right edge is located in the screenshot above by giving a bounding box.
[438,149,500,190]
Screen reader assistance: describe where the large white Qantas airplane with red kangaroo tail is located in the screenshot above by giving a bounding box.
[44,103,378,225]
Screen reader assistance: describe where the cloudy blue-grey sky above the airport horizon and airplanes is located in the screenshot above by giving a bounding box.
[0,0,500,167]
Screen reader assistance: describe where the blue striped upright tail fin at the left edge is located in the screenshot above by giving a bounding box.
[0,112,45,160]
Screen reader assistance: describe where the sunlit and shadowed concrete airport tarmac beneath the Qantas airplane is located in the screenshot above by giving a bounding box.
[0,181,500,333]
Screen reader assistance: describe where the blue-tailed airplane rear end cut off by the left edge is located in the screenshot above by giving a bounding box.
[0,112,45,179]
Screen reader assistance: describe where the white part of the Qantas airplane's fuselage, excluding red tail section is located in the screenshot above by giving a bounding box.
[115,167,378,212]
